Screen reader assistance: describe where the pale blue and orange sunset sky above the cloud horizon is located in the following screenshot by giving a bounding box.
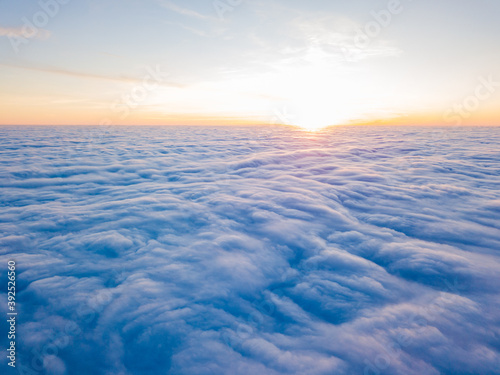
[0,0,500,129]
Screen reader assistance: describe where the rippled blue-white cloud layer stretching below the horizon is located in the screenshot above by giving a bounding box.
[0,127,500,375]
